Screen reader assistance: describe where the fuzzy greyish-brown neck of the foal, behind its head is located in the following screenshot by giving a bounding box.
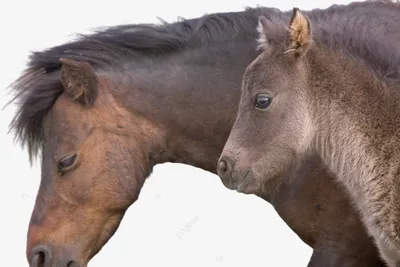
[310,51,400,249]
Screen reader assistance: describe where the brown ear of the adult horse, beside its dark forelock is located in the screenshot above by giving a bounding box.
[60,58,98,106]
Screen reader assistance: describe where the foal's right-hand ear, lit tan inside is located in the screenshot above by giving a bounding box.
[286,7,312,57]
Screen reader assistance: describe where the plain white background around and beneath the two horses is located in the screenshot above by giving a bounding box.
[0,0,349,267]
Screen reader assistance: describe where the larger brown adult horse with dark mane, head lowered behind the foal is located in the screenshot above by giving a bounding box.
[6,3,400,267]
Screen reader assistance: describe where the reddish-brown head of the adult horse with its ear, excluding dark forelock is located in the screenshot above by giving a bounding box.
[27,60,163,266]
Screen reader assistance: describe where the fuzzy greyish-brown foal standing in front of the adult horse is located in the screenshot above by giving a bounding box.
[218,4,400,267]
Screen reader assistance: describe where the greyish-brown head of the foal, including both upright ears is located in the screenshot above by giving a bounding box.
[217,8,312,193]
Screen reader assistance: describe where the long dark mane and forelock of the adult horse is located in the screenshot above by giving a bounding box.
[6,1,400,161]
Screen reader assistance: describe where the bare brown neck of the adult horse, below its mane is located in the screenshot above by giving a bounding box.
[118,40,258,172]
